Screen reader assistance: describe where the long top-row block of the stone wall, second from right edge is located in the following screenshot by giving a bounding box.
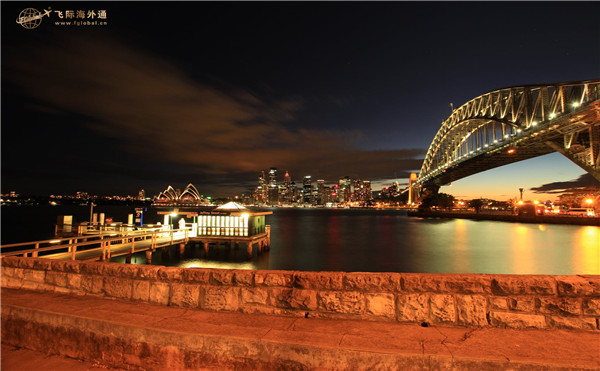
[491,275,556,295]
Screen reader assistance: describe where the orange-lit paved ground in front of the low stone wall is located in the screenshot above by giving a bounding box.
[2,288,600,371]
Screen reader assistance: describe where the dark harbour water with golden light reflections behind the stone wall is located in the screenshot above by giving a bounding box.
[1,206,600,274]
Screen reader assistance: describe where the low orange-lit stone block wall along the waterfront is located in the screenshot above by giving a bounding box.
[1,257,600,331]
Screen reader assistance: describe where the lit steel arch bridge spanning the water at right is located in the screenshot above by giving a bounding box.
[411,80,600,199]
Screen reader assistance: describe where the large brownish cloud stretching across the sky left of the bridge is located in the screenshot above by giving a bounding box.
[3,36,426,196]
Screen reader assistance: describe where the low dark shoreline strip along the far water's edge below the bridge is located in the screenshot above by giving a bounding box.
[407,211,600,226]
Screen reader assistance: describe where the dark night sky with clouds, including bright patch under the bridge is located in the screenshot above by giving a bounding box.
[1,2,600,199]
